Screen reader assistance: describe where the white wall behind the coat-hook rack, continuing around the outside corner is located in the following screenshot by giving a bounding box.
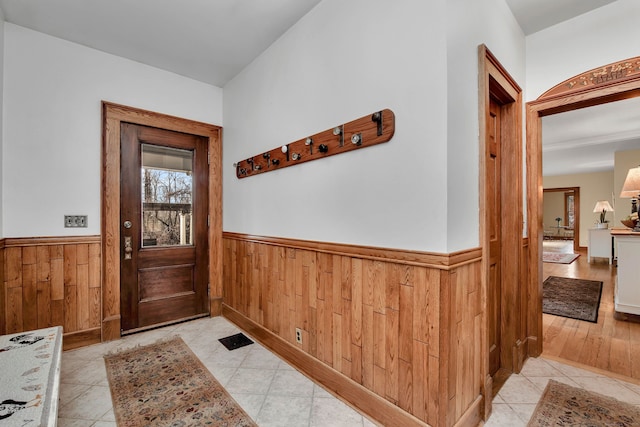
[223,0,524,252]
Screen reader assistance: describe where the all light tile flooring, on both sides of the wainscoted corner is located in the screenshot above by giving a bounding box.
[58,317,640,427]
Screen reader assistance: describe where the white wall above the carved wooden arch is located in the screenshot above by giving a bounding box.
[527,0,640,101]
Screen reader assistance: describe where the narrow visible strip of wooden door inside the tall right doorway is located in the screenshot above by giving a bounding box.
[485,99,502,376]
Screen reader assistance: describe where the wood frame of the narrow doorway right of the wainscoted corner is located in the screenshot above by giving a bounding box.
[478,45,525,419]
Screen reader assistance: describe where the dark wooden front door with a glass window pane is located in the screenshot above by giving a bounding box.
[120,123,209,333]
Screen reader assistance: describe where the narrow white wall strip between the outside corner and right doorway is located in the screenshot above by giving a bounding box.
[446,0,526,252]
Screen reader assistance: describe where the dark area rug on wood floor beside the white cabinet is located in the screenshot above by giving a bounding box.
[542,276,602,323]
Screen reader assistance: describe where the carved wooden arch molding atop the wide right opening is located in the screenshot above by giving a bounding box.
[537,56,640,101]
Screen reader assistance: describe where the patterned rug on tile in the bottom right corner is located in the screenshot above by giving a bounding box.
[528,380,640,427]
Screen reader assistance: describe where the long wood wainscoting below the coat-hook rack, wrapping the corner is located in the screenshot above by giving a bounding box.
[223,233,485,426]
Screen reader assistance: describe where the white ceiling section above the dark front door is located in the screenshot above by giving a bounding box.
[0,0,320,87]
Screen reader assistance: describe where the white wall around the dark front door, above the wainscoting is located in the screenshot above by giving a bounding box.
[2,23,222,237]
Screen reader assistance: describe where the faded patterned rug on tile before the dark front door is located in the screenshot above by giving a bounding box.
[104,337,256,427]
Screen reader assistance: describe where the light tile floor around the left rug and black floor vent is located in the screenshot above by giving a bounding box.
[58,317,375,427]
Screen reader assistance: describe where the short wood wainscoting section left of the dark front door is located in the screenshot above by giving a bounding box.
[0,236,101,348]
